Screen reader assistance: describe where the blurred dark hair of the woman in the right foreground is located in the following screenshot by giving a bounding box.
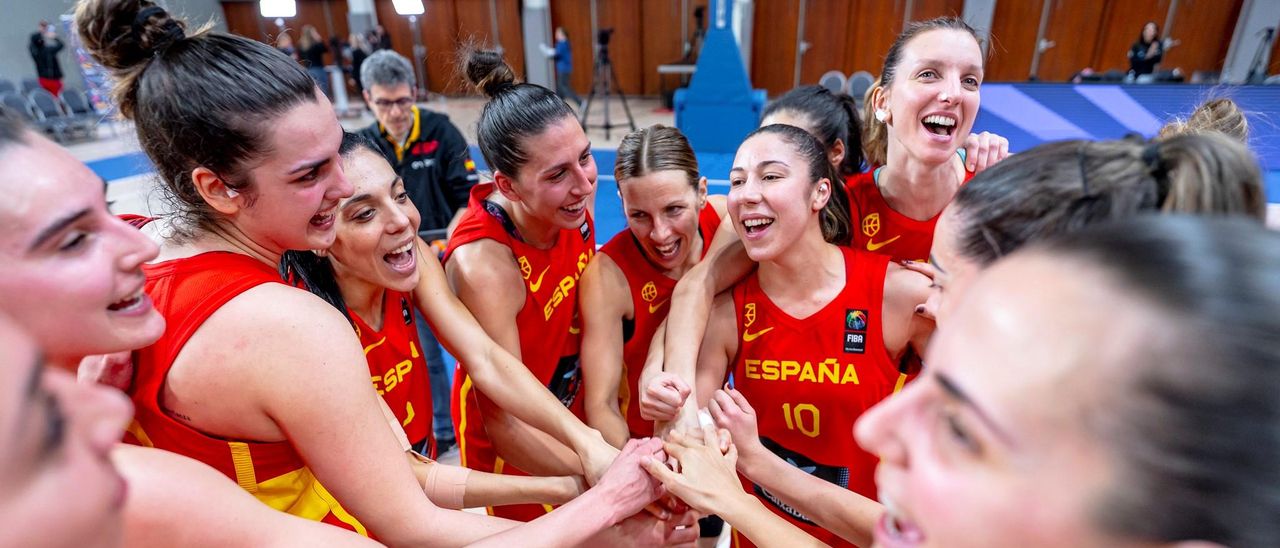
[1034,216,1280,548]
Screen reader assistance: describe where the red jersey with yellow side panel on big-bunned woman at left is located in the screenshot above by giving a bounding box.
[125,250,369,536]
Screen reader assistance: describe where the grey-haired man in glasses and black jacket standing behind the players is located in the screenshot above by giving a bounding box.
[360,50,479,453]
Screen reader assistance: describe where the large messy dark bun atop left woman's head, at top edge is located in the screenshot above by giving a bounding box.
[76,0,187,71]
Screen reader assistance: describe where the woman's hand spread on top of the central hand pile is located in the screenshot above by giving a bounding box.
[643,426,750,513]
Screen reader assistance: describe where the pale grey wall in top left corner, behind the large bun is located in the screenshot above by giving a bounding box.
[0,0,227,88]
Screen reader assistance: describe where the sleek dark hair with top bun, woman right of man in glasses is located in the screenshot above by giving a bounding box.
[461,46,573,178]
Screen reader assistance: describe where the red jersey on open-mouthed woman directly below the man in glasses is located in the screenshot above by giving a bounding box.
[347,289,435,458]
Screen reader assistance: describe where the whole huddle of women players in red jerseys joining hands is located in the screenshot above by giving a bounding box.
[0,0,1280,547]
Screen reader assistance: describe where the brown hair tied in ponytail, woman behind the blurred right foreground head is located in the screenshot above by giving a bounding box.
[950,133,1266,265]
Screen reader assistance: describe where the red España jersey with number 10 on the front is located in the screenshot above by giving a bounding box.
[732,248,906,545]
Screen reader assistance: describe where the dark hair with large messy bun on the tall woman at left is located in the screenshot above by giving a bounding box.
[76,0,320,237]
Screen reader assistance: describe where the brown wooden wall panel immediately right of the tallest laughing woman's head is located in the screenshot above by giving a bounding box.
[983,0,1042,82]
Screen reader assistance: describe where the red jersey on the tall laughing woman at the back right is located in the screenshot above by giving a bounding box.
[845,168,973,261]
